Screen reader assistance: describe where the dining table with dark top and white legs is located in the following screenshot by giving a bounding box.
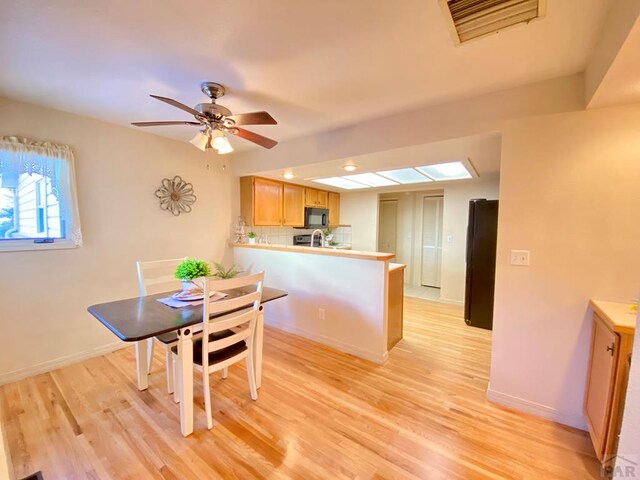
[87,287,287,437]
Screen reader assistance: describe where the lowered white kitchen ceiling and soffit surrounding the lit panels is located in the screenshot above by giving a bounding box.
[256,133,502,192]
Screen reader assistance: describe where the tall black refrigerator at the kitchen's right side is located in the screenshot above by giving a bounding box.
[464,199,498,330]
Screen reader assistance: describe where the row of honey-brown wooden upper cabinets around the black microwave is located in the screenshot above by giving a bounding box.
[240,177,340,227]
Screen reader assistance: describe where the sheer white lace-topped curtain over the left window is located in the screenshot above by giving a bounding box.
[0,136,82,245]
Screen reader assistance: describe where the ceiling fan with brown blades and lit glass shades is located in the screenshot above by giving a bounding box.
[131,82,278,154]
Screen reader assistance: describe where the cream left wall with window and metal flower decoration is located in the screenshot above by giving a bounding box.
[0,95,238,383]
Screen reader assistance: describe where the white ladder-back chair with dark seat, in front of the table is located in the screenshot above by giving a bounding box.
[171,272,264,429]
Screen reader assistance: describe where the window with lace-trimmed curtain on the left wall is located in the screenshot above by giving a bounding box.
[0,137,82,251]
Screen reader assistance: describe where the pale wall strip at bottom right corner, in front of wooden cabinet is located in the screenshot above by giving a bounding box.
[614,312,640,479]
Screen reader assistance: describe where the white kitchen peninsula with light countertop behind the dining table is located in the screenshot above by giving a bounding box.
[230,243,405,364]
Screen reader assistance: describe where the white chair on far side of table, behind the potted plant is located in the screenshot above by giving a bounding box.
[136,257,186,393]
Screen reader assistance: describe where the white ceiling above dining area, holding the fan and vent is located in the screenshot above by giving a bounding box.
[0,0,612,149]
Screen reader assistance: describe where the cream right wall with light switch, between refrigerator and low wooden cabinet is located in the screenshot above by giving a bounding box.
[490,105,640,427]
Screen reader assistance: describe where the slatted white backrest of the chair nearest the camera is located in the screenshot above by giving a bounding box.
[199,272,264,369]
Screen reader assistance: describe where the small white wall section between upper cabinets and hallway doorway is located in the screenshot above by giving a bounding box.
[340,192,378,252]
